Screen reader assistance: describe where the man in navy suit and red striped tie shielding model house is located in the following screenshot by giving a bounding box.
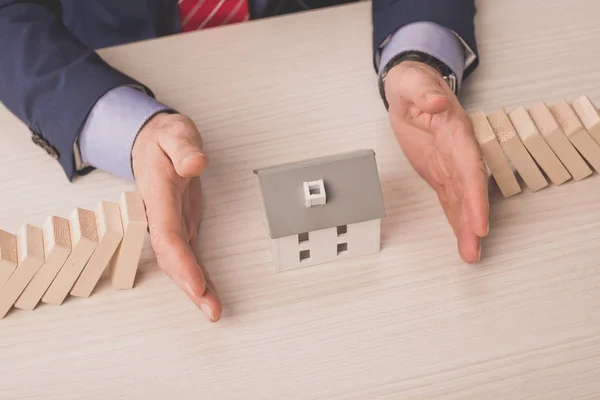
[0,0,488,322]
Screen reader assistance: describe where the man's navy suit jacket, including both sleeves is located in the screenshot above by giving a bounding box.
[0,0,477,179]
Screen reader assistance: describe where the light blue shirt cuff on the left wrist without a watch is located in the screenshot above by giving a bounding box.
[75,86,173,180]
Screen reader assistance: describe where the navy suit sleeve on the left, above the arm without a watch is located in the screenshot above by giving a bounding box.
[0,0,142,180]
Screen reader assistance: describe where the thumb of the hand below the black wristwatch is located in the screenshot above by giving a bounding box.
[386,61,453,114]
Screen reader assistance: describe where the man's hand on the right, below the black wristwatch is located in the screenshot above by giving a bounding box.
[385,61,489,263]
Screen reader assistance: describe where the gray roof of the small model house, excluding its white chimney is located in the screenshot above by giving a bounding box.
[254,150,385,239]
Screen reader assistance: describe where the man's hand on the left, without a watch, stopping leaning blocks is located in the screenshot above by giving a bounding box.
[132,113,222,322]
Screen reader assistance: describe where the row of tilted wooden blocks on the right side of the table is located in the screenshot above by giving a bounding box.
[470,95,600,197]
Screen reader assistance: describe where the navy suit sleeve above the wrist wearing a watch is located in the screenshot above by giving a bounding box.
[372,0,479,79]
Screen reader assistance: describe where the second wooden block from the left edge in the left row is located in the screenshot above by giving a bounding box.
[0,225,44,318]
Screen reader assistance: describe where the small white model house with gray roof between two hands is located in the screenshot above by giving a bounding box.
[255,150,385,271]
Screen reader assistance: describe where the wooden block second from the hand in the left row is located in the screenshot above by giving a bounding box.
[71,201,123,297]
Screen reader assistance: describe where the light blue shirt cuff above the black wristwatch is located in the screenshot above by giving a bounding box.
[378,21,476,87]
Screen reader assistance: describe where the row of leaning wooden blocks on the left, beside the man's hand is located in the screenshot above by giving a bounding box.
[0,192,147,319]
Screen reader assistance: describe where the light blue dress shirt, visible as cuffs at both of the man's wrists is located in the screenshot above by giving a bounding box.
[76,22,475,180]
